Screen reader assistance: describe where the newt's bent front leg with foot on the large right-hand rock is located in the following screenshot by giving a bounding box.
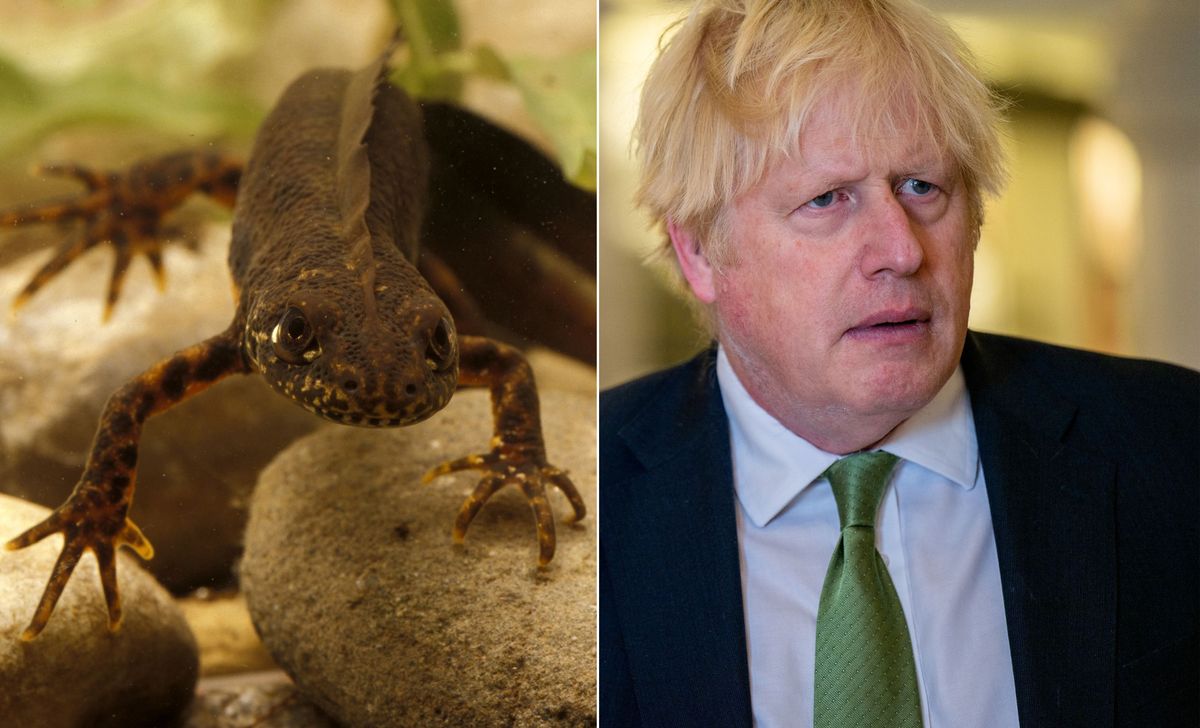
[422,336,587,566]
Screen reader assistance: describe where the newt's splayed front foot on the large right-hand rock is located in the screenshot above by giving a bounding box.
[421,447,587,566]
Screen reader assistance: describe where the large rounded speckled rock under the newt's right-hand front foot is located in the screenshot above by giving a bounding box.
[241,390,596,727]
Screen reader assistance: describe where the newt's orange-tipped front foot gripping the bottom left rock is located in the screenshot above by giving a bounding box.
[5,495,154,642]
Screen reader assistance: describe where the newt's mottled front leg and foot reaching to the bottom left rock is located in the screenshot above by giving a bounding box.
[6,330,247,640]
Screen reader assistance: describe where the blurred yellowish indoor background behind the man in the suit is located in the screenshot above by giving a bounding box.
[599,0,1200,387]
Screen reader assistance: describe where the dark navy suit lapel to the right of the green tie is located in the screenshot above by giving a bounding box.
[962,333,1116,727]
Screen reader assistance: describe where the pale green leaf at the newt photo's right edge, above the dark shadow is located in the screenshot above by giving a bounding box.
[508,50,596,189]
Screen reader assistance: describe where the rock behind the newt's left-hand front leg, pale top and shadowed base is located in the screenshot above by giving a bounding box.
[0,232,318,590]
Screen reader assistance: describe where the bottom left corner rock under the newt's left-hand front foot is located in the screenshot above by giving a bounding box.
[0,495,198,728]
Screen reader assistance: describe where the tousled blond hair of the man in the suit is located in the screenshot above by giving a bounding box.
[635,0,1004,263]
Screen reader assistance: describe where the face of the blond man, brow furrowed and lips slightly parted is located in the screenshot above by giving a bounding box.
[677,101,974,452]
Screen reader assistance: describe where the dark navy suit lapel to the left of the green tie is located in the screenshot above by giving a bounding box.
[602,351,751,727]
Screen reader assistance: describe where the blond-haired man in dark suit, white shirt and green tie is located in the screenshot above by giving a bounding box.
[600,0,1200,728]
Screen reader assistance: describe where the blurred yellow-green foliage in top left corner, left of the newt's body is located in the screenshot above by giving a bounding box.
[0,0,278,157]
